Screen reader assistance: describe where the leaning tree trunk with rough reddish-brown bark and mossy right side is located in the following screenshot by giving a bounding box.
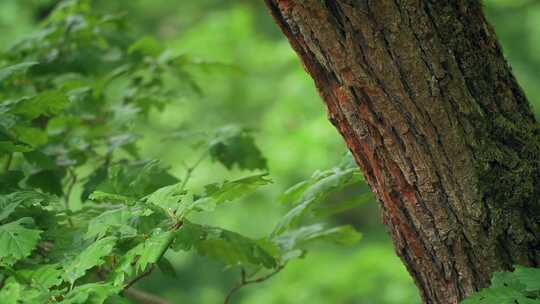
[265,0,540,303]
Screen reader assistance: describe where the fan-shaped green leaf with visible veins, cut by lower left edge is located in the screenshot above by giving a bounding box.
[0,217,42,261]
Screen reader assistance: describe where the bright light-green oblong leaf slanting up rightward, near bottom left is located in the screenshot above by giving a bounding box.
[64,237,116,285]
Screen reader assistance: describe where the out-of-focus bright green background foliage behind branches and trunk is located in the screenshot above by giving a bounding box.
[0,0,540,304]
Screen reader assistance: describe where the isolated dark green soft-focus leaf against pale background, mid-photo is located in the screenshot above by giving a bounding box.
[209,126,267,170]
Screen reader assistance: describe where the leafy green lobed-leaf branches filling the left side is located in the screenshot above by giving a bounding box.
[0,0,360,304]
